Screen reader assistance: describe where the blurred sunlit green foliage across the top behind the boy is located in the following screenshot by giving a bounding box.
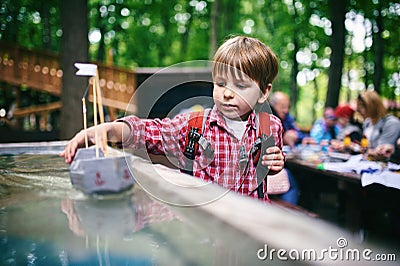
[0,0,400,128]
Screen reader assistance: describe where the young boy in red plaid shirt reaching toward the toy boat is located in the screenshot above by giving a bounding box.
[60,36,284,201]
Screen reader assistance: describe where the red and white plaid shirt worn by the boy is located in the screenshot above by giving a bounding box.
[118,106,283,201]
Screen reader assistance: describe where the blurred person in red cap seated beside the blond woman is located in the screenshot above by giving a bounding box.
[334,104,362,142]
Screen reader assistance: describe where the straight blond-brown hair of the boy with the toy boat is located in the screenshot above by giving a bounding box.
[212,36,278,93]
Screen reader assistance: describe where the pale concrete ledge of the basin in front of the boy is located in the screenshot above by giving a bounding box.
[132,157,366,255]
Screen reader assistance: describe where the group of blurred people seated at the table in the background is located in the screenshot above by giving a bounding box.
[271,90,400,162]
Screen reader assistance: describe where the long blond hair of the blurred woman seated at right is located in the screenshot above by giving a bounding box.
[357,90,388,124]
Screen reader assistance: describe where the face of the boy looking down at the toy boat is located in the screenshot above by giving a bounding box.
[213,71,271,120]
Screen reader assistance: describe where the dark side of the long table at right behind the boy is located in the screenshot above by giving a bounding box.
[286,156,400,242]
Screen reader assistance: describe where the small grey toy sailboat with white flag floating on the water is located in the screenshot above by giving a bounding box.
[69,63,135,194]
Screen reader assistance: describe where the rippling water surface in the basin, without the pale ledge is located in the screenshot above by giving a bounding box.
[0,143,278,265]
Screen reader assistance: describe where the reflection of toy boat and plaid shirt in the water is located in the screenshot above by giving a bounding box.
[61,190,179,238]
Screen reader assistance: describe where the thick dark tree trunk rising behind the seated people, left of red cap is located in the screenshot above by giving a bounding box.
[325,0,348,107]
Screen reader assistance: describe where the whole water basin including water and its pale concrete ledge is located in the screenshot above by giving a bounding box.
[0,142,394,265]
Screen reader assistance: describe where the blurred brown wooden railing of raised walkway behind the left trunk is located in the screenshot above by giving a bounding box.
[0,42,137,114]
